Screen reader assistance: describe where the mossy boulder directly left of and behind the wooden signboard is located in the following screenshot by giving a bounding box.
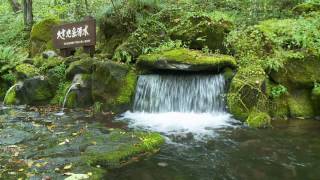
[30,18,60,56]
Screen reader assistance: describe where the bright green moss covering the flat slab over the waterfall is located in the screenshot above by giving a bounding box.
[137,48,237,68]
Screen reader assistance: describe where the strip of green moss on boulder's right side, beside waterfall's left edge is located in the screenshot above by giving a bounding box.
[116,70,138,104]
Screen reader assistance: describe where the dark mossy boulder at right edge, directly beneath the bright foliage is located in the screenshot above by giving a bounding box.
[270,57,320,89]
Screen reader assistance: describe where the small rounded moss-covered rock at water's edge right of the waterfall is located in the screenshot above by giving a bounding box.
[246,111,271,128]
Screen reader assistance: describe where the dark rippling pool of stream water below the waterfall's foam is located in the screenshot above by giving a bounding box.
[111,117,320,180]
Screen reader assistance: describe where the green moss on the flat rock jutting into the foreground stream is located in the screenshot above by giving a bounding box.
[83,131,164,168]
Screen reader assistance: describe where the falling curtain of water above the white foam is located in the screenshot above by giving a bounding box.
[133,75,225,113]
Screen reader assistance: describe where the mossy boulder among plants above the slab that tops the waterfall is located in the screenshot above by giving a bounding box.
[169,13,233,52]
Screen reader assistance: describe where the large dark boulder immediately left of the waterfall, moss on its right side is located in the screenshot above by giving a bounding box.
[92,61,137,112]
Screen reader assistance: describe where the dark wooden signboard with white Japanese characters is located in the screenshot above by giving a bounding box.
[52,18,96,56]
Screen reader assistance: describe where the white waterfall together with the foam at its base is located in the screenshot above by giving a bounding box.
[120,75,232,139]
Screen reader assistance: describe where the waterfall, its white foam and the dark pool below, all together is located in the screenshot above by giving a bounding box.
[114,75,320,180]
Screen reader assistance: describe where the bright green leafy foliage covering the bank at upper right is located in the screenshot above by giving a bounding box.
[227,13,320,71]
